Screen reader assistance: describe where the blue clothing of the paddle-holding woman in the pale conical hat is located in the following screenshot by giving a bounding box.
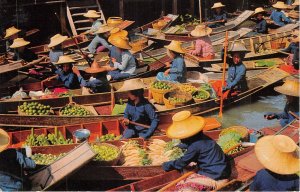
[124,99,159,138]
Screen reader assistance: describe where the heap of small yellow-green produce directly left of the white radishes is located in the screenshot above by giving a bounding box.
[92,145,119,161]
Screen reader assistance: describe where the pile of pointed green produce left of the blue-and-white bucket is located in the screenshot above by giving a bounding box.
[25,127,73,146]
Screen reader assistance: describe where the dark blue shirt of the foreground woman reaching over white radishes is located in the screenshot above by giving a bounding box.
[163,133,230,180]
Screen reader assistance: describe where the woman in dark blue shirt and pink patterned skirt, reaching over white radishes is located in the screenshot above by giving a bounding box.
[162,111,231,191]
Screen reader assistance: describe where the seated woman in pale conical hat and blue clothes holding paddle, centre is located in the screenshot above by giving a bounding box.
[118,79,159,139]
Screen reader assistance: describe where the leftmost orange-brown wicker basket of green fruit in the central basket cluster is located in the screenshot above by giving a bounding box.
[163,90,193,109]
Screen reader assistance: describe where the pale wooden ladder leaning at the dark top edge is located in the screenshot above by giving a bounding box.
[67,0,106,36]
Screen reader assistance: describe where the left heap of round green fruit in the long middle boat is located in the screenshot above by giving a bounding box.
[18,102,51,115]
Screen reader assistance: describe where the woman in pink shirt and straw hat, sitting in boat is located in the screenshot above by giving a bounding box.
[190,25,215,60]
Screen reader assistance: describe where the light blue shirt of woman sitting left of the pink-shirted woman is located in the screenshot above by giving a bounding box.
[169,56,186,83]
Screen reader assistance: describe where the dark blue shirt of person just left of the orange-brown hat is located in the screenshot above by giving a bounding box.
[55,69,80,89]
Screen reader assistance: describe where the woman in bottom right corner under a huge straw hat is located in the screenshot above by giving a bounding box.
[250,135,300,191]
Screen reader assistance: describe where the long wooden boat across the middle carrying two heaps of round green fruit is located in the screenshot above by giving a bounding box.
[0,68,289,126]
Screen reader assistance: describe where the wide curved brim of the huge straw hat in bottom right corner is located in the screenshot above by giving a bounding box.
[255,135,300,175]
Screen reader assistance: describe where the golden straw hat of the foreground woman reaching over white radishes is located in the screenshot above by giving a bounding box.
[166,111,205,139]
